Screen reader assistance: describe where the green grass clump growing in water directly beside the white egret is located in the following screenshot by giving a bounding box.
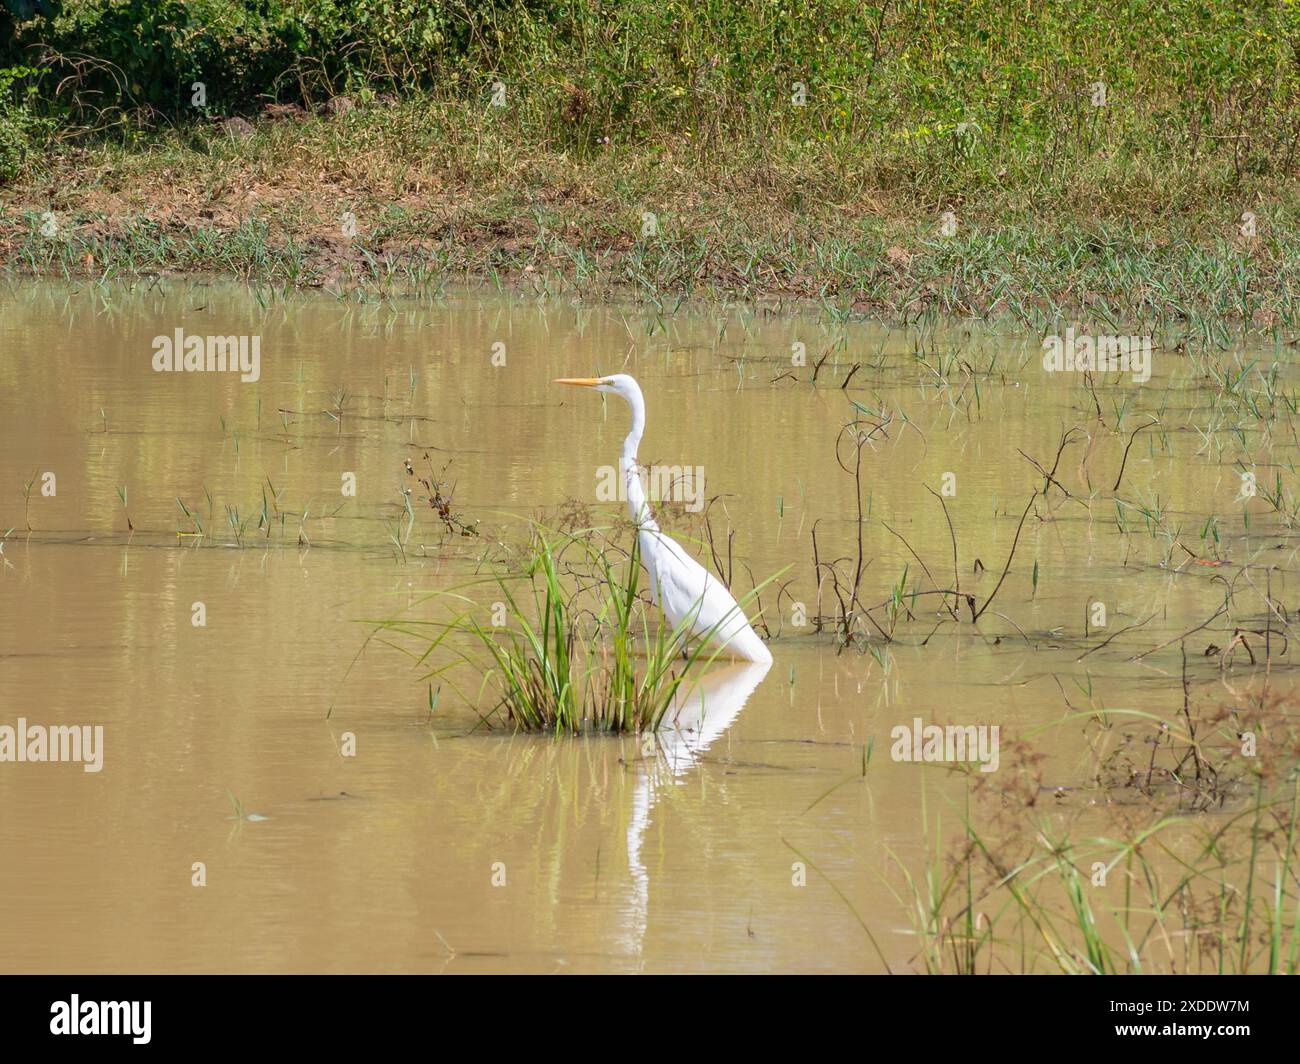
[376,525,761,734]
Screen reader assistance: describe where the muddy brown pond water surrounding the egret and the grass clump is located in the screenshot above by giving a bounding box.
[0,282,1295,972]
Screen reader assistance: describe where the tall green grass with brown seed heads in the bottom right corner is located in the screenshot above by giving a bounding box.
[892,692,1300,974]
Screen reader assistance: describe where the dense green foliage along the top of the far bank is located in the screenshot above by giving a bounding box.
[5,0,1300,138]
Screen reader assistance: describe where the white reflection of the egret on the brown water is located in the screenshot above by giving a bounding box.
[628,662,772,952]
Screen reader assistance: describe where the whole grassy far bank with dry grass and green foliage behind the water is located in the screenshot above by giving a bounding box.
[0,0,1300,331]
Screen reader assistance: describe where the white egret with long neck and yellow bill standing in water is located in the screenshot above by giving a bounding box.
[555,373,772,665]
